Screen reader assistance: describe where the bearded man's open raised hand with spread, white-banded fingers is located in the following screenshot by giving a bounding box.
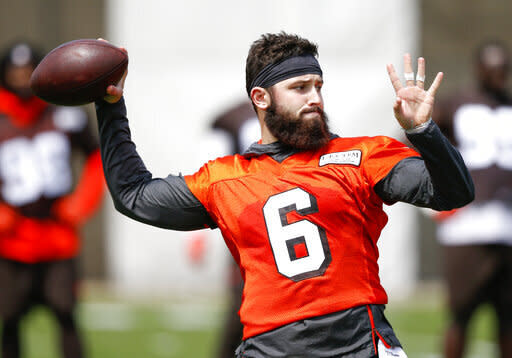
[387,53,443,129]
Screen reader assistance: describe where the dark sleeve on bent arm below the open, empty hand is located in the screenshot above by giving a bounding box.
[375,121,475,210]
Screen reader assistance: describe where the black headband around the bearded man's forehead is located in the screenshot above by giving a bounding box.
[249,55,322,91]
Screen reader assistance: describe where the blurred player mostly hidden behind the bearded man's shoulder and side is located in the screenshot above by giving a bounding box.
[210,101,261,358]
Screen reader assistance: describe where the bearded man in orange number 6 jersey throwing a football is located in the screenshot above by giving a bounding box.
[96,33,473,358]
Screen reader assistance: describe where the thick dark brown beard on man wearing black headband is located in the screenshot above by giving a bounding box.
[265,101,330,149]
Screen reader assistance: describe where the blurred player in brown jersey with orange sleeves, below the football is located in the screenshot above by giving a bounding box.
[0,42,105,358]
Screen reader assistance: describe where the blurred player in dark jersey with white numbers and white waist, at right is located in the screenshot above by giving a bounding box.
[433,42,512,358]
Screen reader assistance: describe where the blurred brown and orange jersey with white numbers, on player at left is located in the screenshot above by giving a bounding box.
[0,89,105,264]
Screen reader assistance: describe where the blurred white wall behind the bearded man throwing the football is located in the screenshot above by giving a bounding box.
[106,0,418,300]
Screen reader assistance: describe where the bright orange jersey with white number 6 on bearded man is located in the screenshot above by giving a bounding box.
[185,136,419,339]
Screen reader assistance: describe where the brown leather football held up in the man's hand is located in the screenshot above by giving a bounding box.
[30,39,128,106]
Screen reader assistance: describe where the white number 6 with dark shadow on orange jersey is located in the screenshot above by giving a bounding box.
[263,188,331,281]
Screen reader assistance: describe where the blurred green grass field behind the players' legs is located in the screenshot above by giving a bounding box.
[7,286,496,358]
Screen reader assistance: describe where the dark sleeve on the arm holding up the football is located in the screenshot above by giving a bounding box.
[96,99,216,230]
